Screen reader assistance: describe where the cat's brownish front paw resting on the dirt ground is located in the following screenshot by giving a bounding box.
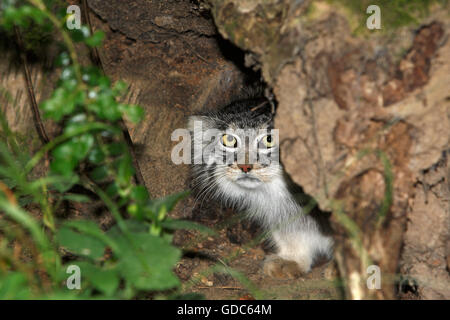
[263,255,306,279]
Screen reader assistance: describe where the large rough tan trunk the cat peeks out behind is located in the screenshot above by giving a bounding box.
[209,0,450,298]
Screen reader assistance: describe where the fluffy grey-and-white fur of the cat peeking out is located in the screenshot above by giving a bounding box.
[189,93,333,273]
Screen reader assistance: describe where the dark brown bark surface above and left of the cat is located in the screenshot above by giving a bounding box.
[88,0,256,221]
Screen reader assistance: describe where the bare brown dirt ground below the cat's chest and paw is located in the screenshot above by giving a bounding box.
[174,210,343,300]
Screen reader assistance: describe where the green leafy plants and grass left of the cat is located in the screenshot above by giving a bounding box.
[0,0,202,299]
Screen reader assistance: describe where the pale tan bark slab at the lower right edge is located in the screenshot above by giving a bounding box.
[401,153,450,299]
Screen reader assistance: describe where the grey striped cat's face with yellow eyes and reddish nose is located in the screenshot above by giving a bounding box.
[189,99,282,196]
